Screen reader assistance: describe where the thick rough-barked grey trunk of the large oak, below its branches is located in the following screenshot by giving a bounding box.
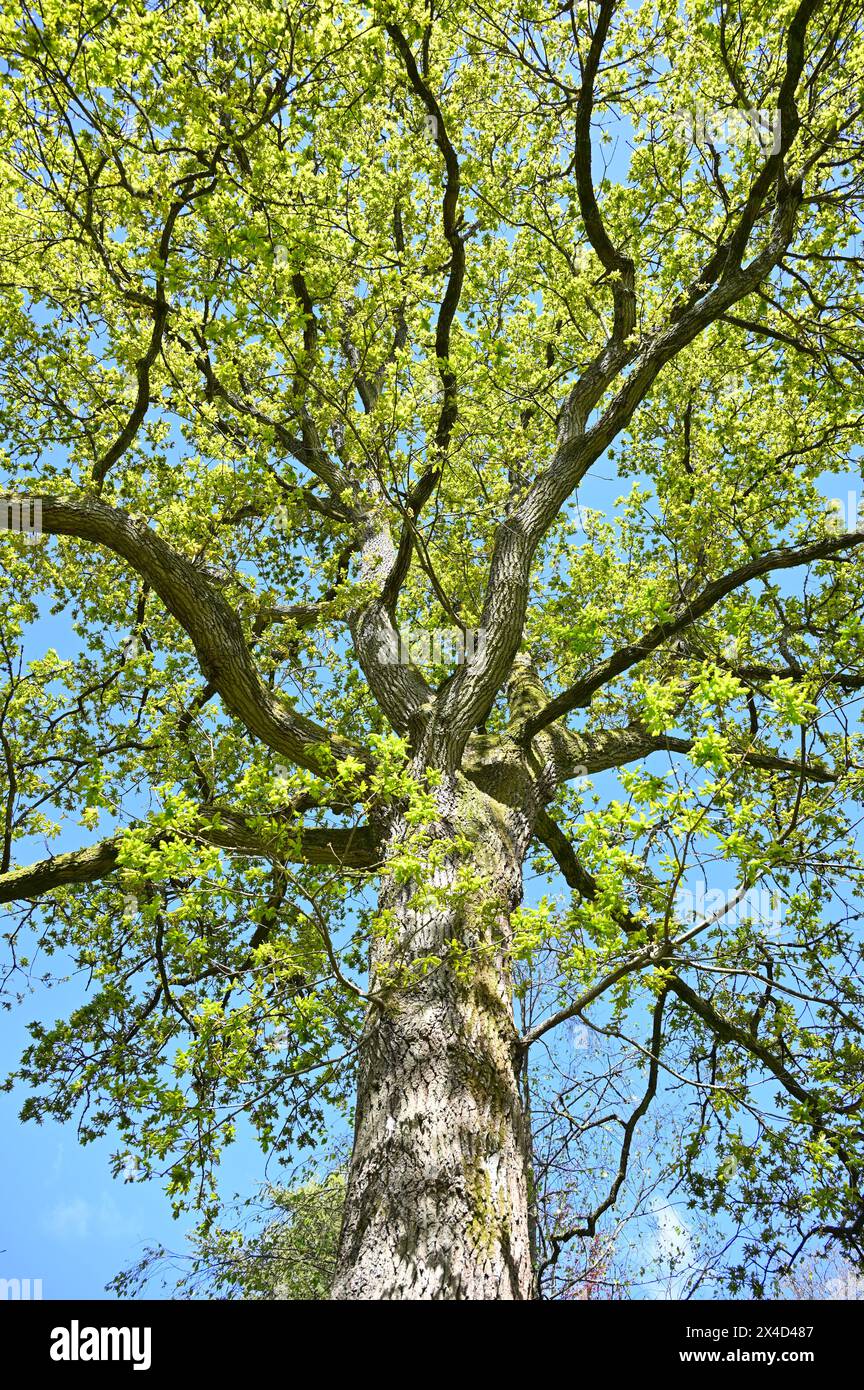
[333,777,531,1300]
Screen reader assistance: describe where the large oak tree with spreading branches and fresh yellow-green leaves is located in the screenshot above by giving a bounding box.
[0,0,864,1300]
